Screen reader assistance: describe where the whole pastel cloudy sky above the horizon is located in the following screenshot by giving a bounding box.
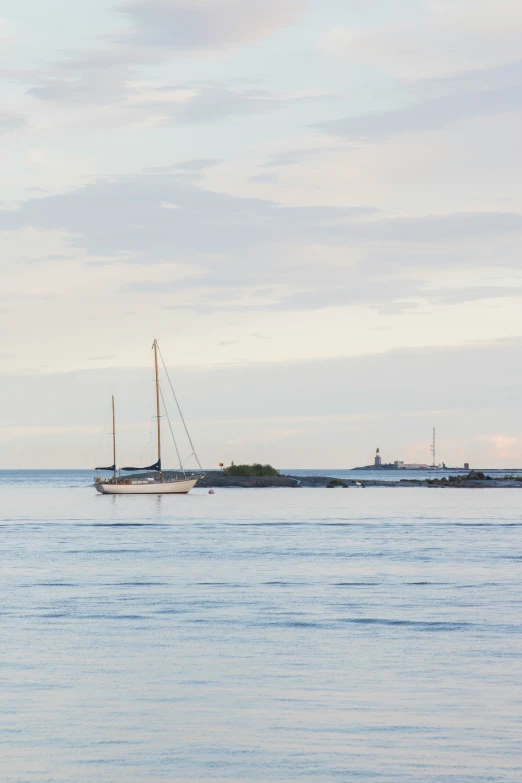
[0,0,522,469]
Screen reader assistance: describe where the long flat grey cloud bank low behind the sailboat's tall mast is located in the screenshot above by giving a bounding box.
[0,339,522,426]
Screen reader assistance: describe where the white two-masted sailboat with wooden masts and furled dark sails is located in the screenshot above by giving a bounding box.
[94,340,201,495]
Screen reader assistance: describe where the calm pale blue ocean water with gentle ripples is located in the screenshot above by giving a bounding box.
[0,471,522,783]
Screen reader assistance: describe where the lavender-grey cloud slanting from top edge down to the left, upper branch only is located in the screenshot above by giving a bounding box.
[16,0,306,89]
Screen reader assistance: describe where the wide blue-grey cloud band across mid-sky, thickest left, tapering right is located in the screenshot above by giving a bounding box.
[0,172,522,263]
